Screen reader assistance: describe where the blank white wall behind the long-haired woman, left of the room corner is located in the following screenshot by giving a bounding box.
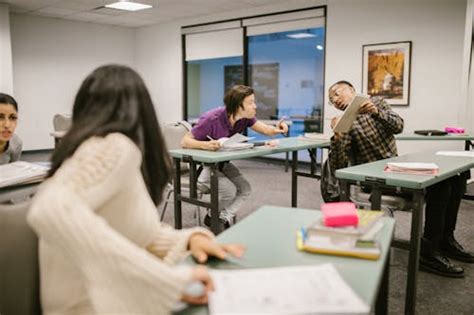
[11,15,135,150]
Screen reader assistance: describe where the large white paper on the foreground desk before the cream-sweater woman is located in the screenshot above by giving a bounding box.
[209,264,370,314]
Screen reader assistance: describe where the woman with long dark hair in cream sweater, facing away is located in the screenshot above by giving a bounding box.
[28,65,243,314]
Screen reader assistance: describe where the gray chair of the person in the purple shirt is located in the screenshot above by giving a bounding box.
[160,120,210,225]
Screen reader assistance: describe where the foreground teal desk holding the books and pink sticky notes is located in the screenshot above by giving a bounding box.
[180,206,395,314]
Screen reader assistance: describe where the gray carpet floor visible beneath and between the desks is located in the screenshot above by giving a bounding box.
[159,161,474,314]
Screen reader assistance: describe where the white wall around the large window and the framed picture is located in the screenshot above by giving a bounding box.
[137,0,474,153]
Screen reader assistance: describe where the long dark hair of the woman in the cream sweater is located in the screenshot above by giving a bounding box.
[48,65,171,205]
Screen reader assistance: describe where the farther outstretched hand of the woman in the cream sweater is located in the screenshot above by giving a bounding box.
[189,233,245,263]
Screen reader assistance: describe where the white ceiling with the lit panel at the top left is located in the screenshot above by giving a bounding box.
[0,0,288,27]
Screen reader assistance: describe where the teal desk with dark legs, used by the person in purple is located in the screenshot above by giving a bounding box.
[169,137,329,233]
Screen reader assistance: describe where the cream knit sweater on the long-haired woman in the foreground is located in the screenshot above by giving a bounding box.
[28,133,212,314]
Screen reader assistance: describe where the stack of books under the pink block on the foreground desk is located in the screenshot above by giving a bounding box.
[297,206,383,260]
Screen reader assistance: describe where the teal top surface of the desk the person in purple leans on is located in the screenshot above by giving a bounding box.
[168,137,330,163]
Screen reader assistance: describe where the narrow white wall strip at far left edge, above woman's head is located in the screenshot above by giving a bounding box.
[0,3,13,94]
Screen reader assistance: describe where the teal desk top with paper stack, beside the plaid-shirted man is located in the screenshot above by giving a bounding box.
[336,153,474,189]
